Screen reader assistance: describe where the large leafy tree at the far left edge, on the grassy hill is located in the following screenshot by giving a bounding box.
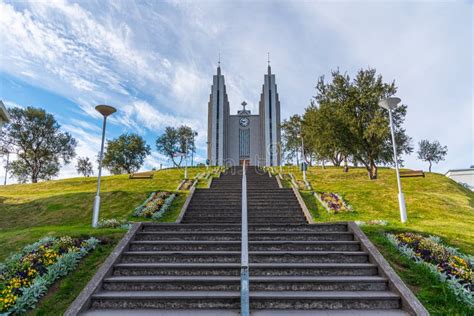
[2,107,77,183]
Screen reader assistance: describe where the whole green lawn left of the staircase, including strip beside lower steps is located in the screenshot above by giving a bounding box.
[0,168,205,315]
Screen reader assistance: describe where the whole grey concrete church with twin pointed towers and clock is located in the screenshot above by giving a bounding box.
[207,63,281,166]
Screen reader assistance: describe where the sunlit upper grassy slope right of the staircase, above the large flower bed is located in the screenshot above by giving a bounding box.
[286,167,474,254]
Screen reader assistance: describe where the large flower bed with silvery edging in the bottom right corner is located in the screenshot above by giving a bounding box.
[387,233,474,307]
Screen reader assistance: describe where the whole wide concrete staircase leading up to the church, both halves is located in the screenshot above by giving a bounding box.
[66,168,426,315]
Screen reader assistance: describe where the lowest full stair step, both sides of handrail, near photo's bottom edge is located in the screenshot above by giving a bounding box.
[92,291,400,309]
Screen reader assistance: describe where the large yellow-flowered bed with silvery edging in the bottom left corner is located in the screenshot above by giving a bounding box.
[0,236,99,315]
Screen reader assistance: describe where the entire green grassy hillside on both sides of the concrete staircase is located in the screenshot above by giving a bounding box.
[0,167,474,315]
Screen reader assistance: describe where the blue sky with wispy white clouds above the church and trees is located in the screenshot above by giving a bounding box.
[0,0,474,183]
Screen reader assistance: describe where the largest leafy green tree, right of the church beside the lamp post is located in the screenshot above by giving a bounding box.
[313,68,413,179]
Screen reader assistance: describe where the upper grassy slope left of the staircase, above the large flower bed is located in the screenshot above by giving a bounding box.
[0,168,205,260]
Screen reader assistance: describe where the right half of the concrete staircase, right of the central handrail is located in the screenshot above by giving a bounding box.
[247,168,403,314]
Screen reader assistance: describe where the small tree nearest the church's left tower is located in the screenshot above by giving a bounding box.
[156,125,197,168]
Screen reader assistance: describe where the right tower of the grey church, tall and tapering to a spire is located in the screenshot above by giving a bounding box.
[259,60,281,166]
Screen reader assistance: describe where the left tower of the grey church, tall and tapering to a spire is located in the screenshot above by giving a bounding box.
[207,62,230,166]
